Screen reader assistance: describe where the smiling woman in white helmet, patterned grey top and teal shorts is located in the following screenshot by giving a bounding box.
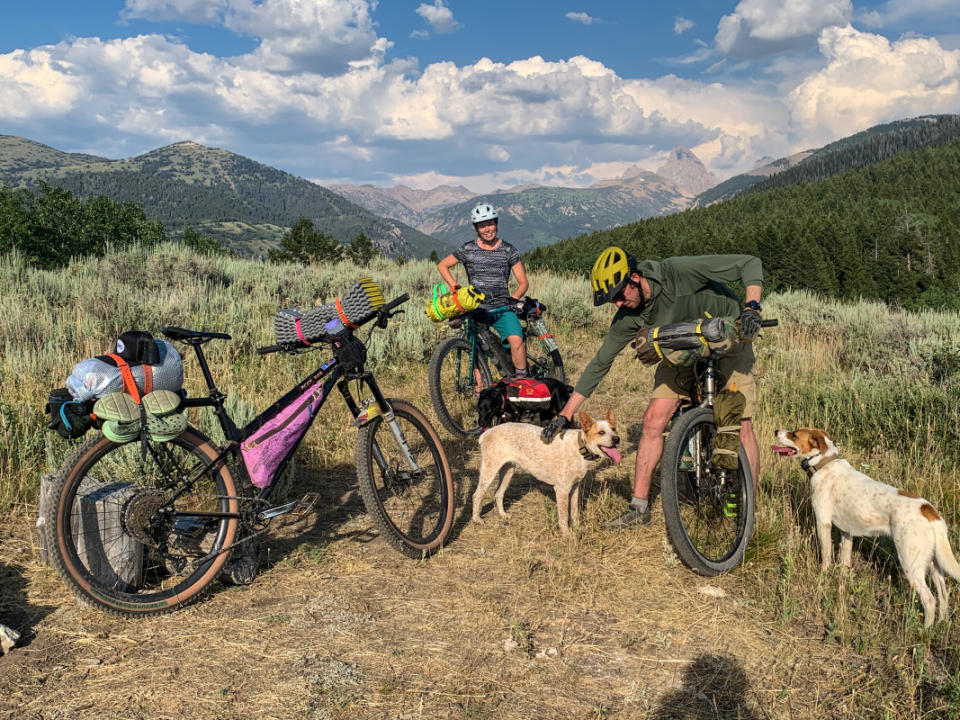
[437,204,529,377]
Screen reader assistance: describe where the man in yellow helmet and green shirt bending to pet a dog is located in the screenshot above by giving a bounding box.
[542,246,763,528]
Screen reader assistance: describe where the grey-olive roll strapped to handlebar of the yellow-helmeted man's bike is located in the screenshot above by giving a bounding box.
[631,318,737,367]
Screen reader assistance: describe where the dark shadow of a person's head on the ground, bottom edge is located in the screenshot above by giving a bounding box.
[653,654,757,720]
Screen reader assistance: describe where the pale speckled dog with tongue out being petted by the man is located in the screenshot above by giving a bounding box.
[473,410,620,536]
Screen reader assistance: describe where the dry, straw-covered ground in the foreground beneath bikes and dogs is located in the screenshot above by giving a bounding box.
[0,428,940,720]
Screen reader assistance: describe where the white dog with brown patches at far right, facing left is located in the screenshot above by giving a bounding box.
[771,428,960,627]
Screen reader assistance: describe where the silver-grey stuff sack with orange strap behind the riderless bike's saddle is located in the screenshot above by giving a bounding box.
[67,333,183,401]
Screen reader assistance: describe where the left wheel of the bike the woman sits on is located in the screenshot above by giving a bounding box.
[427,337,493,438]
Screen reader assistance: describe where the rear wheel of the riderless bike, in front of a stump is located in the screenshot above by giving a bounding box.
[44,428,239,616]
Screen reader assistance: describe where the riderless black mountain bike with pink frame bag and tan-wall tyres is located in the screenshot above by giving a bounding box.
[44,295,454,616]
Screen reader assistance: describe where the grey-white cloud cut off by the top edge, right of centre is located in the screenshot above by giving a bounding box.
[714,0,853,58]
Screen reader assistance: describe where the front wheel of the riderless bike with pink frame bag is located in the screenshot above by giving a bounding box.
[357,400,453,557]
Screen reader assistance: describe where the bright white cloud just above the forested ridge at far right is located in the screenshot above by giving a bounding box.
[787,26,960,140]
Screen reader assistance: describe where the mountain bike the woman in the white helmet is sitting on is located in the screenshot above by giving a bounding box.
[428,298,567,438]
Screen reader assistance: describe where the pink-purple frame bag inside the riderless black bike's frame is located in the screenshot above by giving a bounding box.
[240,376,323,489]
